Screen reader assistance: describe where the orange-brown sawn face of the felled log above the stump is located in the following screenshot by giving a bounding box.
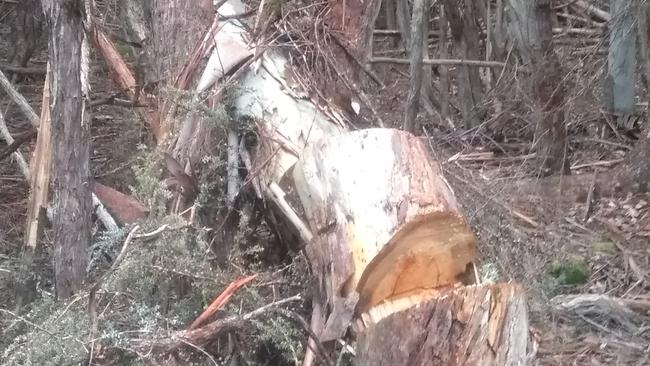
[356,213,476,314]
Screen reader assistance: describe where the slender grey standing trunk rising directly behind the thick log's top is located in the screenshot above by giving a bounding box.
[404,0,429,133]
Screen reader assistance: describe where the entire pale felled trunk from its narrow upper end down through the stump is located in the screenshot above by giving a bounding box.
[140,2,528,365]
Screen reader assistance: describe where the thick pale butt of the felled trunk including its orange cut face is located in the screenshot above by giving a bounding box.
[294,129,475,318]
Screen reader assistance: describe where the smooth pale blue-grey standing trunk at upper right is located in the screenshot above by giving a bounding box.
[605,0,636,128]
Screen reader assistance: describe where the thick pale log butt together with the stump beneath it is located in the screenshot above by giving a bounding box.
[294,129,528,365]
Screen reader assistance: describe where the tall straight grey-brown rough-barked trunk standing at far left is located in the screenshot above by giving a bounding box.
[43,0,91,299]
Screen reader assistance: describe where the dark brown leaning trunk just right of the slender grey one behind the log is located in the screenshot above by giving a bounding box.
[443,0,481,128]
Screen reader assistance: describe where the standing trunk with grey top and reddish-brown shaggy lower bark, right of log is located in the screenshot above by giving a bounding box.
[509,0,569,175]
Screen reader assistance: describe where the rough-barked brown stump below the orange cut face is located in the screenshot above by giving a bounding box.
[356,284,528,366]
